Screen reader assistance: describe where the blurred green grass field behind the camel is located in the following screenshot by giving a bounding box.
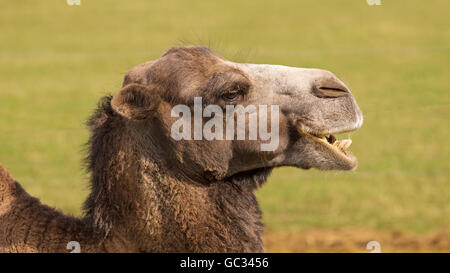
[0,0,450,233]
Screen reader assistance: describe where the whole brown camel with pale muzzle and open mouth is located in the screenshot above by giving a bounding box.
[0,46,363,253]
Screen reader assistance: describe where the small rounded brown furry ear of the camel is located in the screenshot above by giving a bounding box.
[111,83,161,120]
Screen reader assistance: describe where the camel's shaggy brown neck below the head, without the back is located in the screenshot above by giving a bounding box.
[84,98,266,252]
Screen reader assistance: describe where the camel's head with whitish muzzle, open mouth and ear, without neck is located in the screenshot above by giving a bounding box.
[111,47,363,181]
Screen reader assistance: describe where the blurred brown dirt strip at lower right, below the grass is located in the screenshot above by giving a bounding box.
[264,228,450,253]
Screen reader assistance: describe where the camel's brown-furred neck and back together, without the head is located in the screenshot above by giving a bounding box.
[0,97,269,252]
